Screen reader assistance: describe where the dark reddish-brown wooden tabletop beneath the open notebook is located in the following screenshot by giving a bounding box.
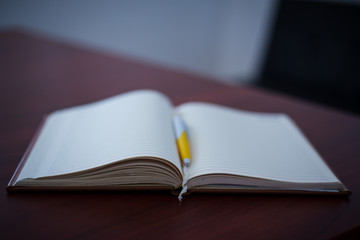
[0,31,360,239]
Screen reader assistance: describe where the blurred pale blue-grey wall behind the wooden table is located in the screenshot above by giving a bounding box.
[0,0,277,83]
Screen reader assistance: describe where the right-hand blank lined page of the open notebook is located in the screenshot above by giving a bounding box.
[176,103,338,183]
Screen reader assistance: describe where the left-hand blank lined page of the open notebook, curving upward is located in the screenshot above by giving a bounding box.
[18,90,181,180]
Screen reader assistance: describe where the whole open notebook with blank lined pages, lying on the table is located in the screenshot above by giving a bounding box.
[7,90,350,195]
